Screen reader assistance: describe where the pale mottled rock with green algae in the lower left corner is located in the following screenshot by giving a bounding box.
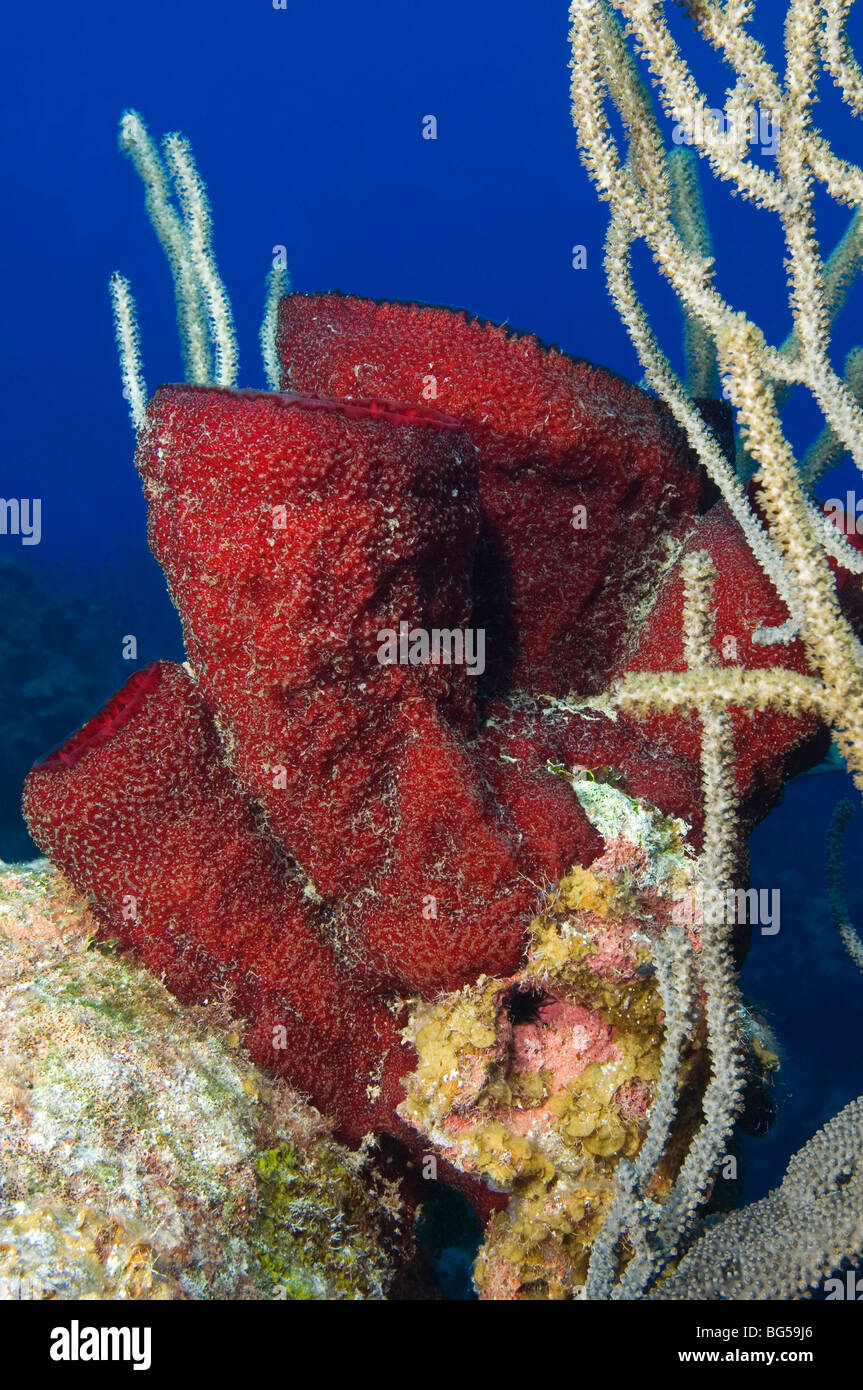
[0,860,413,1300]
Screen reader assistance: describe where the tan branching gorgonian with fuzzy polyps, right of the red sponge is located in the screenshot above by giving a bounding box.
[557,0,863,1298]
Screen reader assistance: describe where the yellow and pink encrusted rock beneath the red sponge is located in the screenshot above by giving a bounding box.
[400,780,703,1298]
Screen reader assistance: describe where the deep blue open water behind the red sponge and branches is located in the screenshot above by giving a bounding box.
[0,0,863,1217]
